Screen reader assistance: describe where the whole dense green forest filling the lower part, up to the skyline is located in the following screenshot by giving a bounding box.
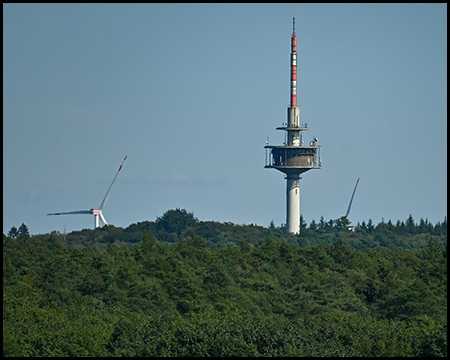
[3,209,447,357]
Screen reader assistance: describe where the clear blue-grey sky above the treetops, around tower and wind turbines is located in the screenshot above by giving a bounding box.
[3,3,447,234]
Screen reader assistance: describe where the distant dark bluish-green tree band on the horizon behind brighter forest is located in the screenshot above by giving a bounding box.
[29,209,447,250]
